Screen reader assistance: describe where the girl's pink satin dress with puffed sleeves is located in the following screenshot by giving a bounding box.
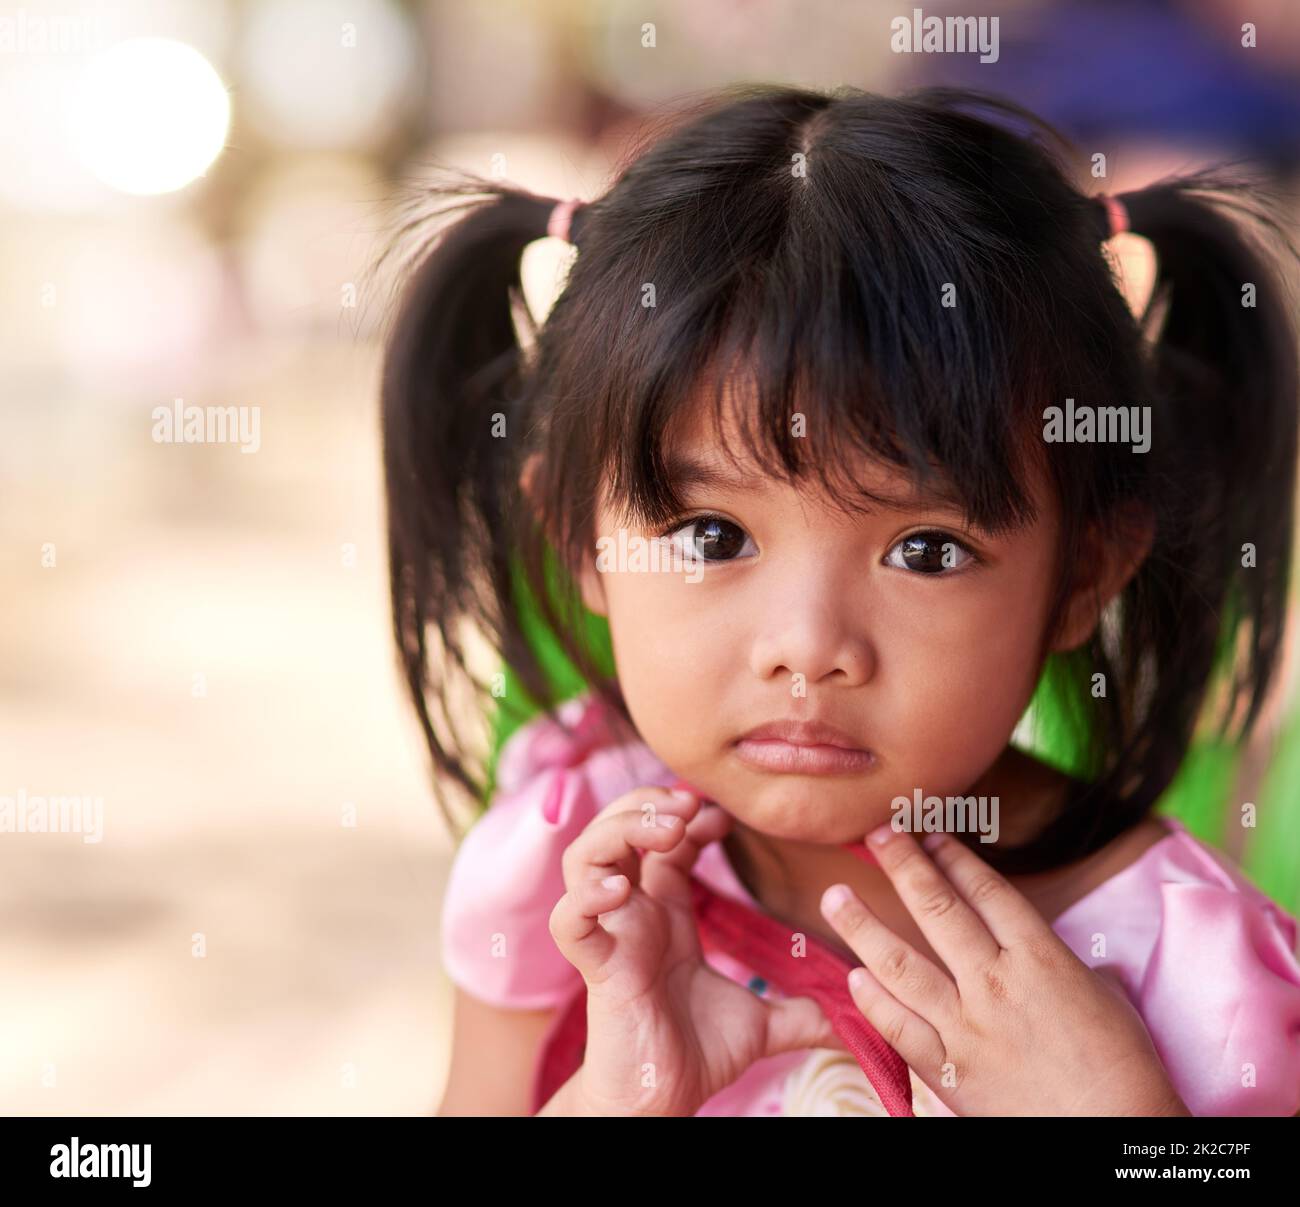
[441,695,1300,1116]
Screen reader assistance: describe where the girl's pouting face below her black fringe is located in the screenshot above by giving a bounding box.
[580,400,1144,843]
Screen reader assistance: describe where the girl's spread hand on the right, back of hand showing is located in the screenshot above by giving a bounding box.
[822,825,1191,1116]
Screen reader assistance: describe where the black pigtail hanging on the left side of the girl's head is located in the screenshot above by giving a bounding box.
[382,178,574,825]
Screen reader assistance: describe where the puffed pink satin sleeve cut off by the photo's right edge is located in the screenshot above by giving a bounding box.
[1138,883,1300,1116]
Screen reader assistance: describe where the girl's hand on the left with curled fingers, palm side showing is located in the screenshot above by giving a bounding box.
[550,787,844,1115]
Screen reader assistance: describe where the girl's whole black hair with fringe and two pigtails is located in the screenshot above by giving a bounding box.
[382,85,1297,873]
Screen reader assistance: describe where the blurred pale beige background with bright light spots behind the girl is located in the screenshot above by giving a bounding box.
[0,0,1300,1115]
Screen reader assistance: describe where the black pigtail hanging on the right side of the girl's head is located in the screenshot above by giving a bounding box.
[1053,170,1297,849]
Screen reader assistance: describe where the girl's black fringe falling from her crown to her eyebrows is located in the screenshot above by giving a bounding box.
[589,137,1062,535]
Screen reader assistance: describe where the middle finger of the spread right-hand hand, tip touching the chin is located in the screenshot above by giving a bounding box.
[870,825,1002,979]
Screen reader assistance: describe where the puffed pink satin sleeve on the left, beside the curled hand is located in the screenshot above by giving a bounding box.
[441,696,670,1009]
